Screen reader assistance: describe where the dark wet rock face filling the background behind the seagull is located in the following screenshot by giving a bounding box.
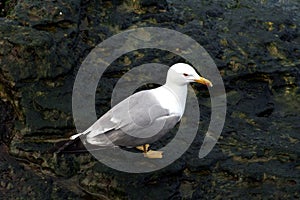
[0,0,300,199]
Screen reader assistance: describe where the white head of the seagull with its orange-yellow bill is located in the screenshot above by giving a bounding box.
[167,63,213,87]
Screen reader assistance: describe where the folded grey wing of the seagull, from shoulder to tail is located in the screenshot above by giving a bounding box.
[84,91,180,146]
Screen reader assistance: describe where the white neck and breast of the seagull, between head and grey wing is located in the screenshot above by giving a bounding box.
[151,86,184,118]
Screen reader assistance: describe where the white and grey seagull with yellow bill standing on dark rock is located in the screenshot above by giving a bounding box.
[59,63,213,158]
